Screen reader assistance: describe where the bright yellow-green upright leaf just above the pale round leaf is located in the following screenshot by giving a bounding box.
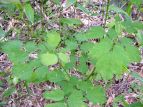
[47,31,61,49]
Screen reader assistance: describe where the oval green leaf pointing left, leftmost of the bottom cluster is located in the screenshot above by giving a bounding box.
[43,89,64,101]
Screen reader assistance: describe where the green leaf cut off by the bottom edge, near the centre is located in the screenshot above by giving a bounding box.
[67,90,87,107]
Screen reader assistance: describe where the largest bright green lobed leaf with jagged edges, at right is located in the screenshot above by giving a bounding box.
[88,39,134,80]
